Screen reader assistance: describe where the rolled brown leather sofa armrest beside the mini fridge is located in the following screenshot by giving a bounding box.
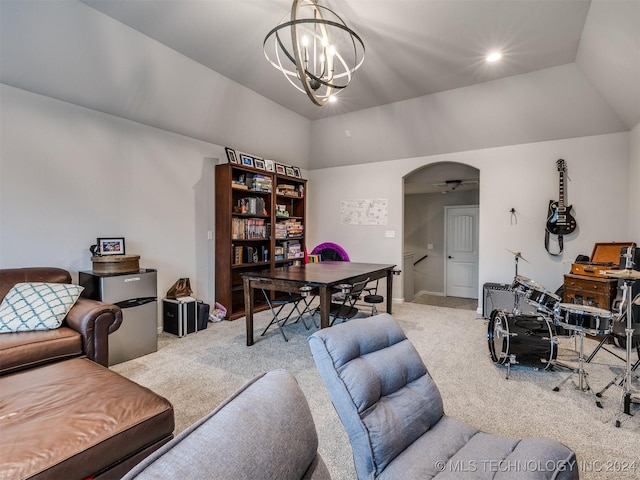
[65,297,122,367]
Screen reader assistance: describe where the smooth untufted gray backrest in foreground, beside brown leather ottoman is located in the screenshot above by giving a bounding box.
[123,370,329,480]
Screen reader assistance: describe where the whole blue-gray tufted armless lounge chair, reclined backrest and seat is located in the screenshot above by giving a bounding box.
[309,313,578,480]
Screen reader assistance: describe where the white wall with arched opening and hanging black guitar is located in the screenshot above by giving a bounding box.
[309,133,640,299]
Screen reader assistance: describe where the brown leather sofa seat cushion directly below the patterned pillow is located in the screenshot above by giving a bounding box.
[0,327,83,374]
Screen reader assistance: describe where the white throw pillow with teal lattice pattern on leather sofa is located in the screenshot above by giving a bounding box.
[0,282,84,333]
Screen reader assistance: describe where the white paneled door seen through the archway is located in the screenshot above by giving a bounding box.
[445,205,479,298]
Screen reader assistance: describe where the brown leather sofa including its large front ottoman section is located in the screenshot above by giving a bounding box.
[0,268,174,479]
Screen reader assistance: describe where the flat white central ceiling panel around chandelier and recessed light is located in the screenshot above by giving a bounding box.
[83,0,591,120]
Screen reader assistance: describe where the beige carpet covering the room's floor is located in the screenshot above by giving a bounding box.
[112,303,640,480]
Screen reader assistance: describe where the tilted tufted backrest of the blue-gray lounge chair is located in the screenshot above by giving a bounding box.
[309,313,444,479]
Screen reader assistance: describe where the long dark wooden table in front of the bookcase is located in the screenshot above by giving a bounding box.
[242,262,395,346]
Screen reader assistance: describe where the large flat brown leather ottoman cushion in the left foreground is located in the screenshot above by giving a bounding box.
[0,358,174,479]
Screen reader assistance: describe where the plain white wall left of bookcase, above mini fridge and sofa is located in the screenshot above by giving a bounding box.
[0,85,226,308]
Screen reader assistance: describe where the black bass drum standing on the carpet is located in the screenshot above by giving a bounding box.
[487,310,558,370]
